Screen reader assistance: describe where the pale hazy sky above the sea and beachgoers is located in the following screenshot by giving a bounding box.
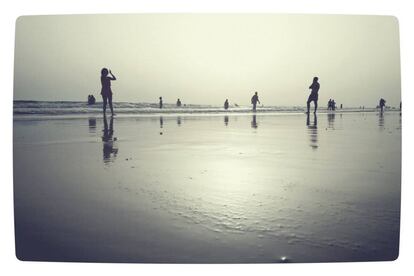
[14,14,401,106]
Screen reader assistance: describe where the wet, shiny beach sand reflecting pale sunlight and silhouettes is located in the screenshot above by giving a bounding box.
[14,112,401,263]
